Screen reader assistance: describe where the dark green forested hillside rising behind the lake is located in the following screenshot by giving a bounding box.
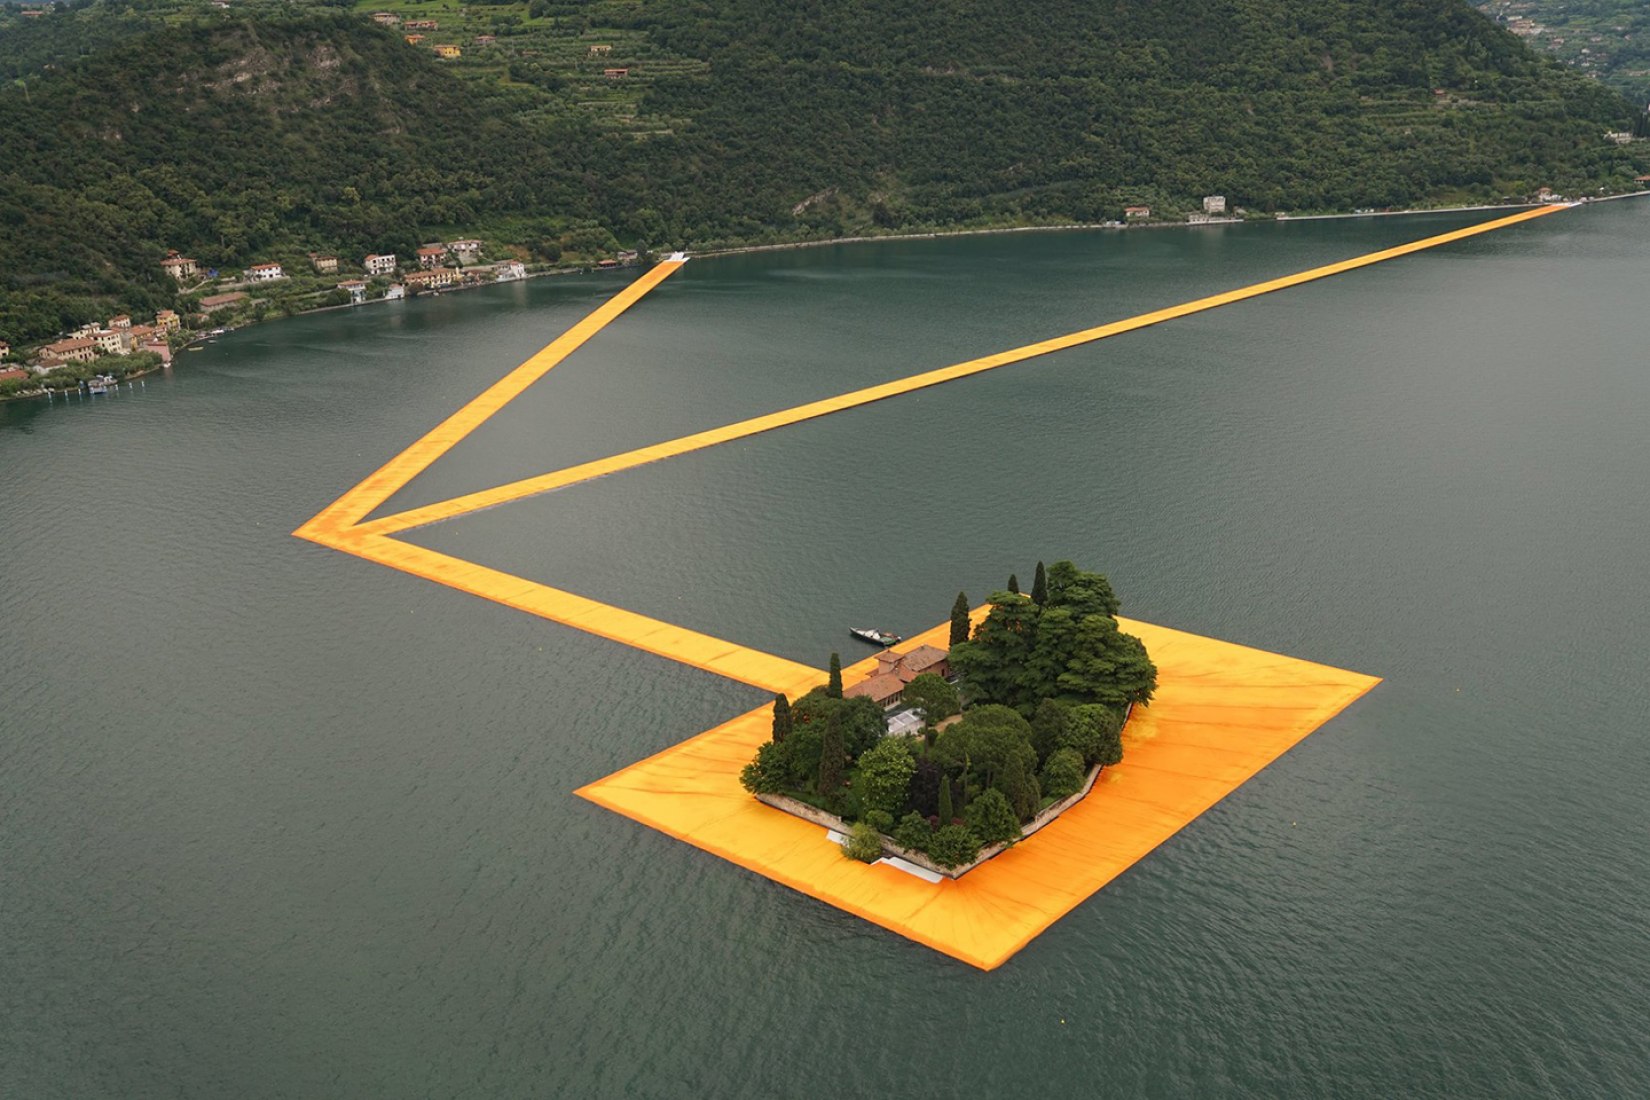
[0,0,1645,343]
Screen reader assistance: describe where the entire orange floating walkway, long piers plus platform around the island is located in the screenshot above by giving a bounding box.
[294,206,1566,970]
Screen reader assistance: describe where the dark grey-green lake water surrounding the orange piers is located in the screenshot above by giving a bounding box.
[0,203,1650,1098]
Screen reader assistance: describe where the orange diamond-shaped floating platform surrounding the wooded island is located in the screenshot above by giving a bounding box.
[578,618,1379,970]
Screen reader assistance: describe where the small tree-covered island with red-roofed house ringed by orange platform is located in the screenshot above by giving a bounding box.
[739,561,1157,882]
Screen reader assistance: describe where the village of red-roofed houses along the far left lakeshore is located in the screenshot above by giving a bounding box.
[0,239,639,401]
